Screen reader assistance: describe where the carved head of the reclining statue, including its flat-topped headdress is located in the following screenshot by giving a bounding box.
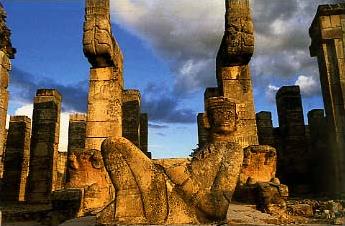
[206,97,237,138]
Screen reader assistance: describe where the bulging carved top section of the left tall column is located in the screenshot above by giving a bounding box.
[83,0,123,70]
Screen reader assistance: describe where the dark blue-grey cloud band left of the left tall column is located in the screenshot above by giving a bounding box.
[10,67,87,112]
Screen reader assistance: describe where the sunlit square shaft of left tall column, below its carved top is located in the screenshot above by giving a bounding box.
[85,67,123,150]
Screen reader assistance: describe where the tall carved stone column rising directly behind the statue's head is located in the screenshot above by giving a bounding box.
[216,0,258,148]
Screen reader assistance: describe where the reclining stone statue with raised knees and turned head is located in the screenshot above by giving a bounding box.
[97,97,243,225]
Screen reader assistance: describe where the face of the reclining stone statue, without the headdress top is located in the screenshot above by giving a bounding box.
[208,104,236,134]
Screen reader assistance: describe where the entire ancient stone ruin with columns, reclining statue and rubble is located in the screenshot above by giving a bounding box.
[0,0,345,225]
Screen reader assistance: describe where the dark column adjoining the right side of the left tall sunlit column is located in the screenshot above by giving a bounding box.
[122,89,141,148]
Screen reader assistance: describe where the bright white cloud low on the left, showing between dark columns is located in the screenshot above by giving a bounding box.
[15,104,71,152]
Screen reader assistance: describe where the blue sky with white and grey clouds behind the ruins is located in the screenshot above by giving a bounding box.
[1,0,337,158]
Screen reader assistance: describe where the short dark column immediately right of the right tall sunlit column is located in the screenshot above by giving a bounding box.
[256,111,275,147]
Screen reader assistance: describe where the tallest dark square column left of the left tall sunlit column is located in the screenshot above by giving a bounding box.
[27,89,61,203]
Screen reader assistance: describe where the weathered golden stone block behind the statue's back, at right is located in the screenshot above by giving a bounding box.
[234,145,289,208]
